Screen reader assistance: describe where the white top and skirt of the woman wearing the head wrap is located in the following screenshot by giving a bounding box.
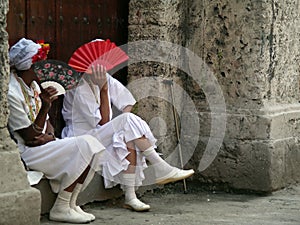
[8,73,105,193]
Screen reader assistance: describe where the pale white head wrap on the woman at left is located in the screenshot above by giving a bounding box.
[9,38,41,70]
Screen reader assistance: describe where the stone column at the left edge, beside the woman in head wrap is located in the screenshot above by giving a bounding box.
[0,0,41,225]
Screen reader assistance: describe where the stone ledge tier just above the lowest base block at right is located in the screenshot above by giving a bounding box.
[199,104,300,141]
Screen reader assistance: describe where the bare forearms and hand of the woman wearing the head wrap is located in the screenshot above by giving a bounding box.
[16,87,57,147]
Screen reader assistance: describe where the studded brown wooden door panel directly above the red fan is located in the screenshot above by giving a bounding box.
[57,0,127,61]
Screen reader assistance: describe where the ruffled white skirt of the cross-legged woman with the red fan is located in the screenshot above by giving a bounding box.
[73,113,156,188]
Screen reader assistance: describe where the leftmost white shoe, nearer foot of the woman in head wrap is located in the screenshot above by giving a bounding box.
[49,207,91,223]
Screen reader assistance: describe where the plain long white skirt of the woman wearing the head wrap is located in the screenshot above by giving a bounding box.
[21,135,105,193]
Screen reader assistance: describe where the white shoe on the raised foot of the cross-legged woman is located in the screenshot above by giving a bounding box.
[156,167,195,184]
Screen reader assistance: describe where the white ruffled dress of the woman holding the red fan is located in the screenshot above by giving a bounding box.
[62,74,156,188]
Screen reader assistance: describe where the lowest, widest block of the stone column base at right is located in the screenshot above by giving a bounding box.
[194,138,300,192]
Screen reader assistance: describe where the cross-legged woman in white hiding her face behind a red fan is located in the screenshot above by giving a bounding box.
[62,53,194,211]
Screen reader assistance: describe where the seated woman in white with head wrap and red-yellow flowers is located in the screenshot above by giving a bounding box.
[8,38,105,223]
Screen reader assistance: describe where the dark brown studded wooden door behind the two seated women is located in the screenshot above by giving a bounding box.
[7,0,129,136]
